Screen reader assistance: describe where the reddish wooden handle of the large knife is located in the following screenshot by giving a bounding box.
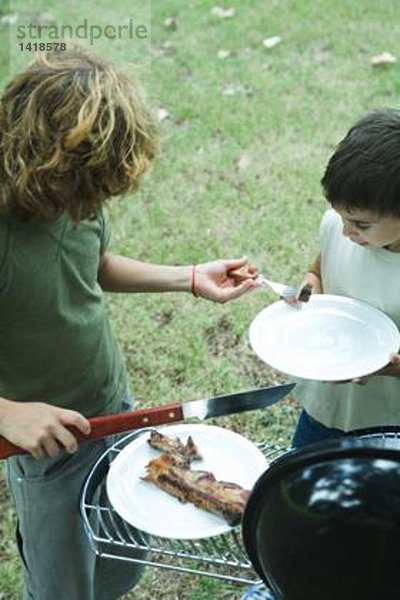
[0,404,183,459]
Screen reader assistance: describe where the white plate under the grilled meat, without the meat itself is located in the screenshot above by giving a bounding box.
[107,424,268,539]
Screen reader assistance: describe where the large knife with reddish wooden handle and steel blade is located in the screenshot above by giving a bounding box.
[0,383,295,459]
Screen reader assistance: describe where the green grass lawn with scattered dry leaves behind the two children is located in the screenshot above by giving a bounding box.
[0,0,400,600]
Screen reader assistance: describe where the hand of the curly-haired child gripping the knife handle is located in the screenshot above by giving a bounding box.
[0,399,90,458]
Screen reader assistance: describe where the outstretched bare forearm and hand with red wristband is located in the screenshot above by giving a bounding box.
[98,252,257,302]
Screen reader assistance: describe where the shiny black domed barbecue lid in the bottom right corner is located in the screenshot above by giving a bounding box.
[243,431,400,600]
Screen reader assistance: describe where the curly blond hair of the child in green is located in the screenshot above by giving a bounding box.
[0,47,157,222]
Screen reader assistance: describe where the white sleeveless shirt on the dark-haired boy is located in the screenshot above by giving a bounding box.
[295,210,400,431]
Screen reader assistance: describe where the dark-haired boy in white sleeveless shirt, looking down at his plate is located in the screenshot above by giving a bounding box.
[293,109,400,446]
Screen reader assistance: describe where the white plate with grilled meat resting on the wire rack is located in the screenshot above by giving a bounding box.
[107,423,268,539]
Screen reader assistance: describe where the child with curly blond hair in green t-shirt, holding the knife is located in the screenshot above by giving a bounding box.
[0,48,255,600]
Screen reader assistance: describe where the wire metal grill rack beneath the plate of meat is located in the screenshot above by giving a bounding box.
[81,429,286,584]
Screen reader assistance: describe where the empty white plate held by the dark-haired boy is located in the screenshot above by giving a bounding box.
[249,294,400,381]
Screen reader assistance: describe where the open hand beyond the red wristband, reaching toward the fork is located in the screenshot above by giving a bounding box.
[195,257,257,303]
